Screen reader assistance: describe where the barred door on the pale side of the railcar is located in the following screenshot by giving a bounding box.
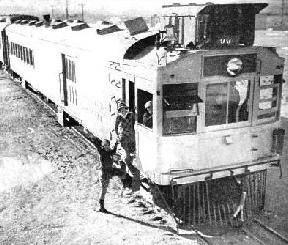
[61,54,78,107]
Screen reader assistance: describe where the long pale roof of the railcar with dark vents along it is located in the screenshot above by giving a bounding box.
[7,22,154,60]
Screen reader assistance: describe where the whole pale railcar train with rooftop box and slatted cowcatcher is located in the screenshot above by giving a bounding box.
[0,2,285,224]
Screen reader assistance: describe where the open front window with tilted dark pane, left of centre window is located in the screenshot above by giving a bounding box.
[163,83,202,135]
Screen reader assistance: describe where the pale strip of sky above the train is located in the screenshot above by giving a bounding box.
[0,0,288,16]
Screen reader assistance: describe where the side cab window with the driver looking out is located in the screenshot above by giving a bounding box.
[137,89,153,128]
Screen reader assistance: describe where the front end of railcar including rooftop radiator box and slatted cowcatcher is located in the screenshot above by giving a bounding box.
[137,4,285,224]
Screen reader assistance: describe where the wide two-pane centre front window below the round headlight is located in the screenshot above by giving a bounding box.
[205,80,250,127]
